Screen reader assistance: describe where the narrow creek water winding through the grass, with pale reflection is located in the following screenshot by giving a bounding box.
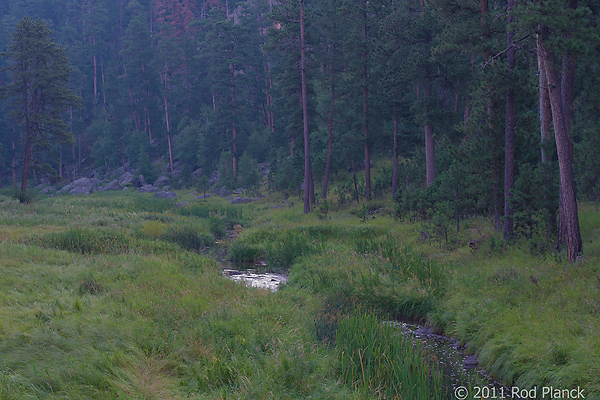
[222,262,511,400]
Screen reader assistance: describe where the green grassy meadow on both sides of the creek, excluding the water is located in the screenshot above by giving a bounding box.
[0,191,600,399]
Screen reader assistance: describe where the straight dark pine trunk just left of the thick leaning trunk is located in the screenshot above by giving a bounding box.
[502,0,517,240]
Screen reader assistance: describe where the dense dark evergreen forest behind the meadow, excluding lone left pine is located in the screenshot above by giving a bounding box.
[0,0,600,260]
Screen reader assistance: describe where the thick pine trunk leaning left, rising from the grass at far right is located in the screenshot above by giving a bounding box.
[540,38,583,261]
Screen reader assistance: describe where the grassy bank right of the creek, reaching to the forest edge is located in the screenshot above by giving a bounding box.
[230,196,600,398]
